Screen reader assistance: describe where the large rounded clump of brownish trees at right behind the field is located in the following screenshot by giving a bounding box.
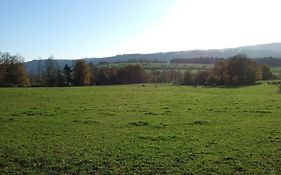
[180,55,272,86]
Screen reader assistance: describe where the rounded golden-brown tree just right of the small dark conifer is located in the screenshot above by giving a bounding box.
[73,60,91,86]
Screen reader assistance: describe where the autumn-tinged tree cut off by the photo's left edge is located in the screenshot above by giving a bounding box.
[0,53,30,86]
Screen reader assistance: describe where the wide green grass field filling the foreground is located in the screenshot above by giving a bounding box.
[0,84,281,174]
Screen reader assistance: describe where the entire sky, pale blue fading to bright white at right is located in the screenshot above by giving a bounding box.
[0,0,281,61]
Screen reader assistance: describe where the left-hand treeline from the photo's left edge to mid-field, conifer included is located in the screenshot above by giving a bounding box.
[0,53,149,87]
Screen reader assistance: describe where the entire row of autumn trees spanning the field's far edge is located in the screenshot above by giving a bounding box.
[0,53,272,86]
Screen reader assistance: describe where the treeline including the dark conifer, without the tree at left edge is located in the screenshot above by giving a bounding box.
[30,59,147,86]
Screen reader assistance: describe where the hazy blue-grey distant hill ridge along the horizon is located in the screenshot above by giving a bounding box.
[25,43,281,73]
